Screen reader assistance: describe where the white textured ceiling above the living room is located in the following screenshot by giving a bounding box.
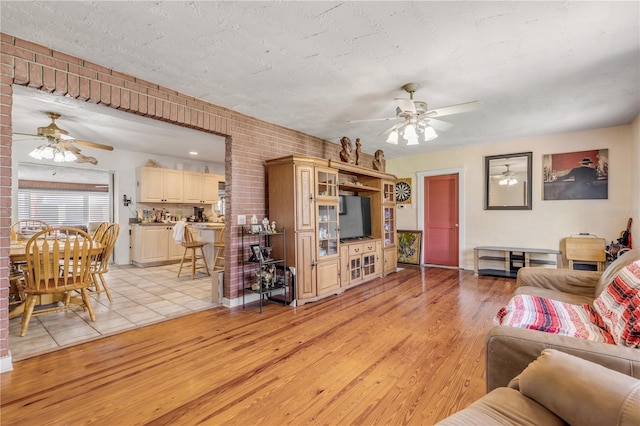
[0,0,640,159]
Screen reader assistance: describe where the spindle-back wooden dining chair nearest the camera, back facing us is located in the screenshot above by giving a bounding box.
[20,227,96,336]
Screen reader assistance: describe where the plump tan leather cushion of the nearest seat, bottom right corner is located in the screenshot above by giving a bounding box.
[518,349,640,425]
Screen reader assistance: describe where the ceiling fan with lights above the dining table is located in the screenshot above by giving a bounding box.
[13,112,113,164]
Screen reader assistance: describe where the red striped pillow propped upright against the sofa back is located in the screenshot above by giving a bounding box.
[593,261,640,348]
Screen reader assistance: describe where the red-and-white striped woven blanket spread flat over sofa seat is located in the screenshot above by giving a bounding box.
[494,294,614,343]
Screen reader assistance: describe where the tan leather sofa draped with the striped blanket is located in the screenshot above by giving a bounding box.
[486,249,640,392]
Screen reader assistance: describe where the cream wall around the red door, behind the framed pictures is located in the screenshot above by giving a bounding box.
[386,124,640,269]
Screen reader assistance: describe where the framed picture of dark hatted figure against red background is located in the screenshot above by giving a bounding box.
[542,149,609,200]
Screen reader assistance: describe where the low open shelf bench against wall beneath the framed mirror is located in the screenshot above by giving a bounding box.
[473,246,562,278]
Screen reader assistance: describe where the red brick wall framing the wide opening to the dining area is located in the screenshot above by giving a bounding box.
[0,33,373,357]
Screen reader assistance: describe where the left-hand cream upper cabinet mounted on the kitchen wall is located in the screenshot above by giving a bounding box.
[138,167,184,203]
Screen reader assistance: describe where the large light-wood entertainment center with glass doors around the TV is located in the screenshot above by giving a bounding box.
[265,156,397,305]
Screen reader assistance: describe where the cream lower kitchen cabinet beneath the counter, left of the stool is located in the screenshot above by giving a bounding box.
[131,225,184,266]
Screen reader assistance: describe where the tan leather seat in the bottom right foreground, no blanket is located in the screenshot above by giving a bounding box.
[437,349,640,426]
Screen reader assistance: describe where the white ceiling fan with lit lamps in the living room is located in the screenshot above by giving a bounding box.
[349,83,482,145]
